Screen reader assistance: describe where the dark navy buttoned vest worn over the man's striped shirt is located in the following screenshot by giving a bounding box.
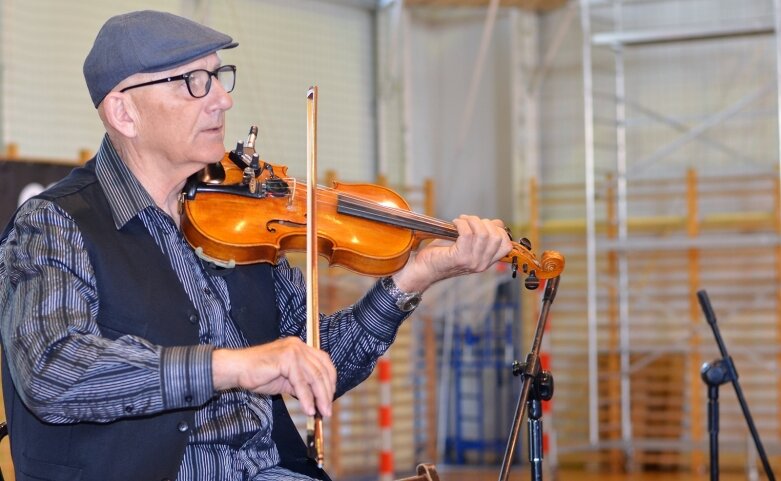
[2,159,328,481]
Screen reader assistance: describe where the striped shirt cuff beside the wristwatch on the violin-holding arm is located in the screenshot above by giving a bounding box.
[353,281,412,343]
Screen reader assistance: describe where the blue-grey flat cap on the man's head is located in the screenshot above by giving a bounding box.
[84,10,238,108]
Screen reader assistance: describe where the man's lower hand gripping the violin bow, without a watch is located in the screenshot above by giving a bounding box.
[212,337,336,416]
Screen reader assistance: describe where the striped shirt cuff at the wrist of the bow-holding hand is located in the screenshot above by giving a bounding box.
[160,345,214,409]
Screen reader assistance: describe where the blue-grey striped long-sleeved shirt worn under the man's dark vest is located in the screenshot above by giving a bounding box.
[0,136,407,481]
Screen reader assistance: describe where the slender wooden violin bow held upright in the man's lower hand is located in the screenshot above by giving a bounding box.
[306,86,325,468]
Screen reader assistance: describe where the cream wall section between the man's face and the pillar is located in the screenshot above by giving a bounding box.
[208,0,376,181]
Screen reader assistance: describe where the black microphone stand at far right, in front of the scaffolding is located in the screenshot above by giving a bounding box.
[697,290,776,481]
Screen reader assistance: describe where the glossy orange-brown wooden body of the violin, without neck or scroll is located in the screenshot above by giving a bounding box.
[182,160,420,275]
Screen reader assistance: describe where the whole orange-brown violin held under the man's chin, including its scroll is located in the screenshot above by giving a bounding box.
[180,127,564,289]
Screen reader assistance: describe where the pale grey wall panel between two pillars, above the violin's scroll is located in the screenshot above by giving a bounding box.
[400,9,512,219]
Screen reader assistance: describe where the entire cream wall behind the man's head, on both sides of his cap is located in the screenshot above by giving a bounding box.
[0,0,376,180]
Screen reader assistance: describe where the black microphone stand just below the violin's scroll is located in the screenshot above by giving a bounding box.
[499,276,560,481]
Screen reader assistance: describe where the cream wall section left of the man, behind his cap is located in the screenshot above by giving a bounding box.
[0,0,166,159]
